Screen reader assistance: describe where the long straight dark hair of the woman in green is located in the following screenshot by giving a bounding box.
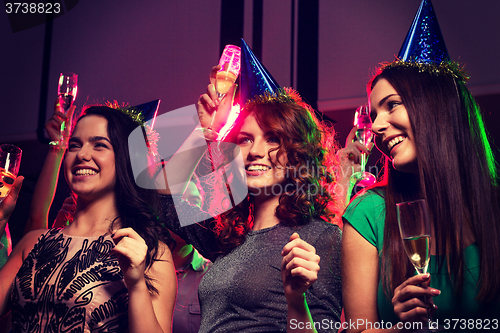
[368,67,500,302]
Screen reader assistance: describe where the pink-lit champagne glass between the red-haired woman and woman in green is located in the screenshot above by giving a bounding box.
[350,105,377,187]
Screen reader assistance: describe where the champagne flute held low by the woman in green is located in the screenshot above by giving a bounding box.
[396,199,432,331]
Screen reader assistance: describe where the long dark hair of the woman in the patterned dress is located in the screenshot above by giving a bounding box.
[73,106,172,292]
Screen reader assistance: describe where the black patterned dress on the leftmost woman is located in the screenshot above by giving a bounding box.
[11,229,128,333]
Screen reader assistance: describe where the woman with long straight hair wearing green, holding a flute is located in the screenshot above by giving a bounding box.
[342,63,500,331]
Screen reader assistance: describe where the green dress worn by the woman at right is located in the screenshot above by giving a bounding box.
[343,190,500,330]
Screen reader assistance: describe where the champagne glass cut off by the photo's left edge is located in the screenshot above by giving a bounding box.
[0,144,22,203]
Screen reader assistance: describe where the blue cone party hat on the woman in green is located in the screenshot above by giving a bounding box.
[398,0,450,64]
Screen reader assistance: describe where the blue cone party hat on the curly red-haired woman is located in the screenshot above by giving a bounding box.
[240,38,281,105]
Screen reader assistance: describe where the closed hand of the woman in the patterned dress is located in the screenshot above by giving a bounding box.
[111,228,148,291]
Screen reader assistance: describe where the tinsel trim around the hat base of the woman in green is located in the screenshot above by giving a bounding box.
[380,59,469,82]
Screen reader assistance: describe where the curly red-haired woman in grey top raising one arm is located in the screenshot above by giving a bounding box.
[157,67,348,332]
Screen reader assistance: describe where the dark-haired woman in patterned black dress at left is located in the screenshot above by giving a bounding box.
[0,106,176,332]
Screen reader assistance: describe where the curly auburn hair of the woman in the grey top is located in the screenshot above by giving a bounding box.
[215,101,339,253]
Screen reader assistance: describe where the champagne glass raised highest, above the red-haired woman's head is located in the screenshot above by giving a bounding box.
[203,45,241,140]
